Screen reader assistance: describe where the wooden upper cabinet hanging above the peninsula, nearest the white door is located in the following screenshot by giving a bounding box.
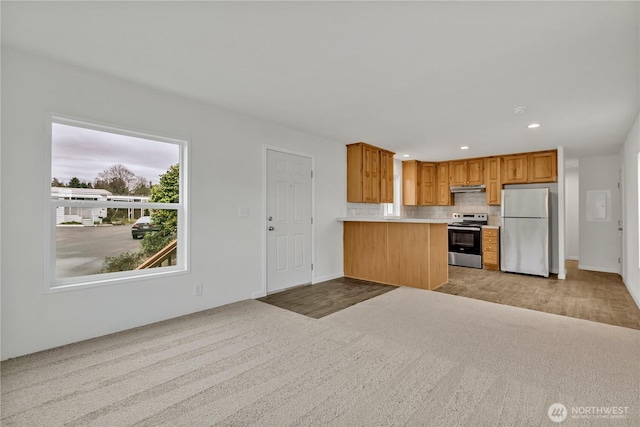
[347,142,394,203]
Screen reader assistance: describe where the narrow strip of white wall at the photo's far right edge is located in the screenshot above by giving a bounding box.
[620,115,640,307]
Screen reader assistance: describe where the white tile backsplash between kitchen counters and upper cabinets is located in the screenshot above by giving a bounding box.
[347,192,500,225]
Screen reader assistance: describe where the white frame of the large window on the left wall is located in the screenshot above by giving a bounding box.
[44,113,190,293]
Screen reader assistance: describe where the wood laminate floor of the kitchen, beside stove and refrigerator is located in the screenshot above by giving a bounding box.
[436,260,640,329]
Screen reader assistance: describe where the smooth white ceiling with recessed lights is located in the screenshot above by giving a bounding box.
[1,1,640,161]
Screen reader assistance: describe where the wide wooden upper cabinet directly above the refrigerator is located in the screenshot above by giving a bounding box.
[502,150,558,184]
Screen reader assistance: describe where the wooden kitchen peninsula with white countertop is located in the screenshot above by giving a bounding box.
[337,217,451,289]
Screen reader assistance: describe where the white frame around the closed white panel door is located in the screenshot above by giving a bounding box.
[251,144,316,299]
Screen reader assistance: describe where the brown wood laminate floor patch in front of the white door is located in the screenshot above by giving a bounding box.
[258,277,396,319]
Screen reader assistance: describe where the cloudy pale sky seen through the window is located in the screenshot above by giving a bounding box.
[51,123,180,184]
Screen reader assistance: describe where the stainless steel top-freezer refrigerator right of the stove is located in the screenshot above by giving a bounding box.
[500,188,549,277]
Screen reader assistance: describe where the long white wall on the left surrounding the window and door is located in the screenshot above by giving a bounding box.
[1,47,346,359]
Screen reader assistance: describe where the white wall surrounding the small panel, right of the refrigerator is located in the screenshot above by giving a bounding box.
[578,155,620,273]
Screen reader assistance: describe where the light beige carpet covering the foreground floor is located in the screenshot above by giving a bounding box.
[1,288,640,426]
